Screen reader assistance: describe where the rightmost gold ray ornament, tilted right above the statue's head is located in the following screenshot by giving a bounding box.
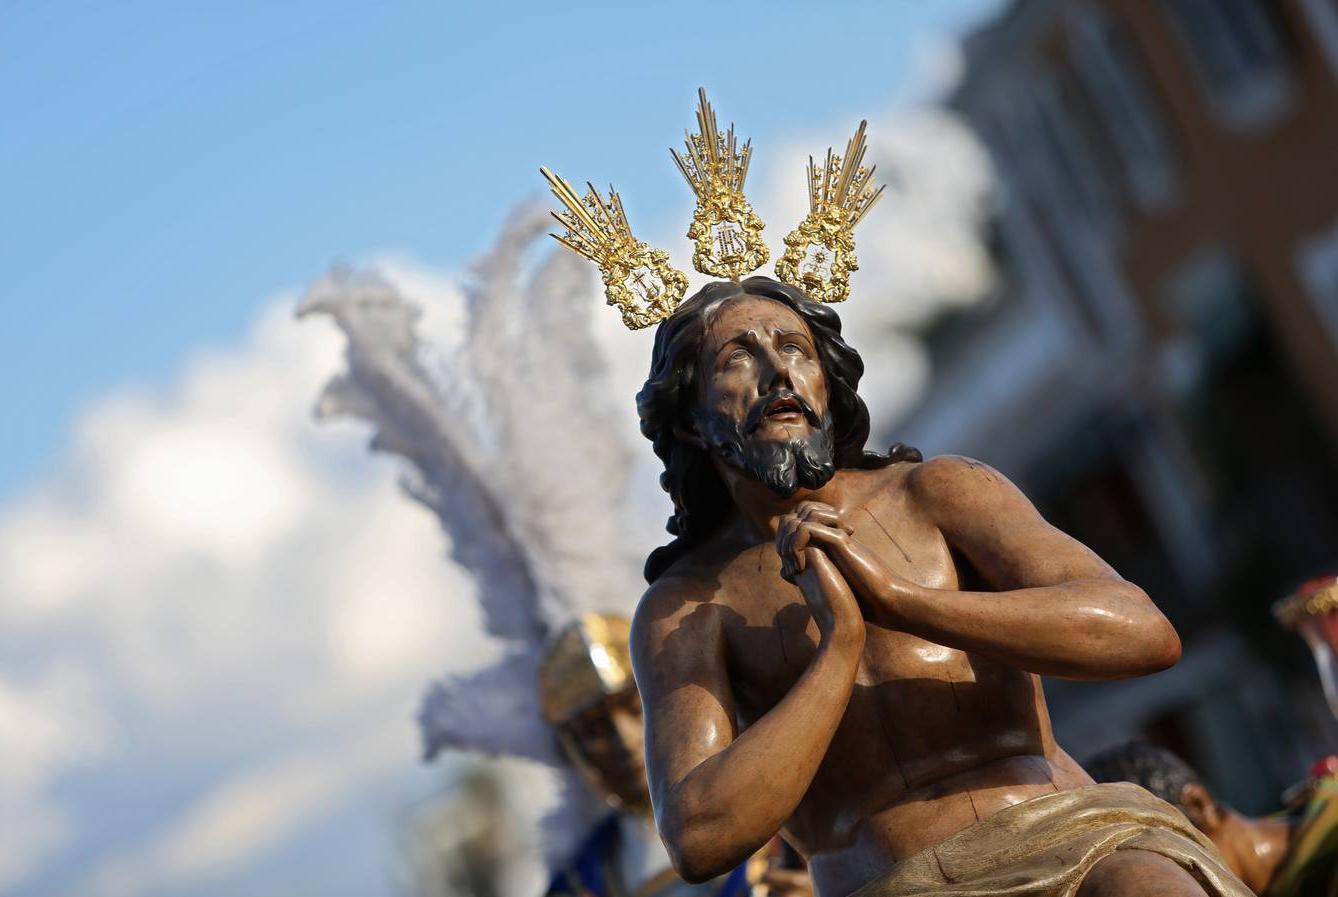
[776,122,883,303]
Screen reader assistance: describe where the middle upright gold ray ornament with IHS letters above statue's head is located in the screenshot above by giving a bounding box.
[669,88,771,280]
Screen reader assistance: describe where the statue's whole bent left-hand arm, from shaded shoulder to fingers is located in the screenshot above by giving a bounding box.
[632,549,864,882]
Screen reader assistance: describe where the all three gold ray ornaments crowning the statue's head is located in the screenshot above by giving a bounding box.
[539,90,883,329]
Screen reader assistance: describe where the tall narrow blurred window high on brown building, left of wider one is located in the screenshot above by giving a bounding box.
[1070,8,1176,209]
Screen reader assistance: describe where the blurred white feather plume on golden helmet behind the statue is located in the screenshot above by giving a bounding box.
[298,208,641,860]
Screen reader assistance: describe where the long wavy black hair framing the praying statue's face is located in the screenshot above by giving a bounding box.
[637,277,921,582]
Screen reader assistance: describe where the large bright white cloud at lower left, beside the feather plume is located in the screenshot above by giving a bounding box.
[0,273,488,893]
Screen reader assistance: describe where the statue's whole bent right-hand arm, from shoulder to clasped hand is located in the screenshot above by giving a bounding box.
[789,457,1180,679]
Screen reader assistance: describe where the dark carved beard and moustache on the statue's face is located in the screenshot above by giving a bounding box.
[698,390,836,498]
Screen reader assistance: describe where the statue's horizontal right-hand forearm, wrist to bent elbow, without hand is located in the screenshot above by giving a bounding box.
[876,578,1180,679]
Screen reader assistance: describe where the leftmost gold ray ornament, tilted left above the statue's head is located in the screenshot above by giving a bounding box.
[539,167,688,331]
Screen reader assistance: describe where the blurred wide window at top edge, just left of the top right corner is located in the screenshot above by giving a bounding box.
[1167,0,1290,130]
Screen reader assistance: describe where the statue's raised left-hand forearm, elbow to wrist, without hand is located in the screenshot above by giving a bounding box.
[658,632,863,881]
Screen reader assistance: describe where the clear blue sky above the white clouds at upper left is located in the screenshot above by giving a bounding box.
[0,0,997,497]
